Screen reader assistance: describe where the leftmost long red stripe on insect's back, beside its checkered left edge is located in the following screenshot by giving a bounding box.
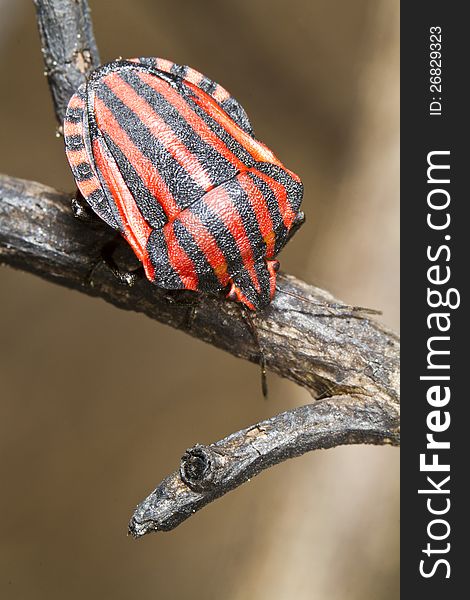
[93,139,155,280]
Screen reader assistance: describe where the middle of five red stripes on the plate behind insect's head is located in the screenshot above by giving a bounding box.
[202,187,261,292]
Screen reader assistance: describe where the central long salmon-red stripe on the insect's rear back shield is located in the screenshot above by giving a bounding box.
[104,73,213,191]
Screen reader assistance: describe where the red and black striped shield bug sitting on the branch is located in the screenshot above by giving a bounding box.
[64,58,304,310]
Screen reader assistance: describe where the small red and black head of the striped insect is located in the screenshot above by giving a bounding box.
[227,259,279,310]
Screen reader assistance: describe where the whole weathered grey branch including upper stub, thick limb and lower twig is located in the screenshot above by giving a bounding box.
[0,0,399,536]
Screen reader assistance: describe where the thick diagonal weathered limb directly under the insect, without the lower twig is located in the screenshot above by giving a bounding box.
[0,176,399,406]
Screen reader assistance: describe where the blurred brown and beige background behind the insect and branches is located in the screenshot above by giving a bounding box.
[0,0,399,600]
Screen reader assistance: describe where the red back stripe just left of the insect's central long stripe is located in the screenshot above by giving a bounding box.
[95,97,180,220]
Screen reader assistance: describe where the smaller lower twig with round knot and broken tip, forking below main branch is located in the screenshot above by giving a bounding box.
[129,396,399,538]
